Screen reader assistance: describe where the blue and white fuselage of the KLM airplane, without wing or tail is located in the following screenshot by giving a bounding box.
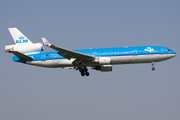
[13,46,176,67]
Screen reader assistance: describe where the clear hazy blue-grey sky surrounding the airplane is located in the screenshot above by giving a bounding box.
[0,0,180,120]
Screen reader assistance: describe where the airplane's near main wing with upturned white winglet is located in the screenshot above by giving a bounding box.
[42,38,95,60]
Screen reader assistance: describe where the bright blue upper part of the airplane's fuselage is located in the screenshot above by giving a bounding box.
[13,46,176,61]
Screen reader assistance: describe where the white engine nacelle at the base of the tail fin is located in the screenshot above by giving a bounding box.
[5,43,44,54]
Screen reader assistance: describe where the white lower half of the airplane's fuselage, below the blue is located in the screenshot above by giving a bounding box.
[26,54,174,68]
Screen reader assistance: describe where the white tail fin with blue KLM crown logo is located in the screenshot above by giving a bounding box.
[8,28,33,44]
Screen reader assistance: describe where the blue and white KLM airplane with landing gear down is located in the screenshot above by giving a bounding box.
[5,28,176,76]
